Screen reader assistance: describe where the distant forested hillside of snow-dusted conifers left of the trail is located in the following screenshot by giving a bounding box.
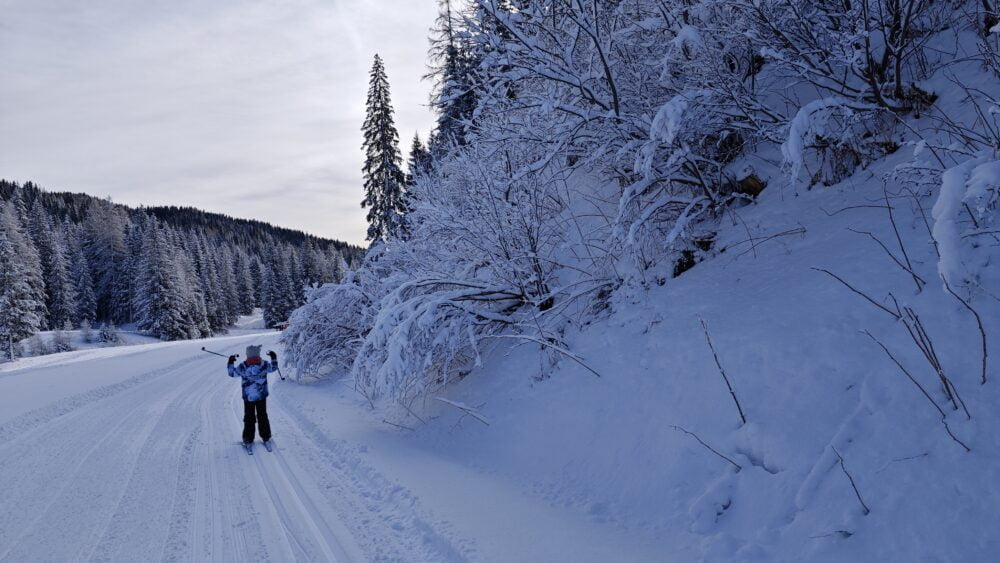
[0,181,361,355]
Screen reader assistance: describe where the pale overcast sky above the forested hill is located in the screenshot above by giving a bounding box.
[0,0,436,243]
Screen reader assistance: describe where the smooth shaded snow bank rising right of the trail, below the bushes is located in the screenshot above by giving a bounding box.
[316,150,1000,561]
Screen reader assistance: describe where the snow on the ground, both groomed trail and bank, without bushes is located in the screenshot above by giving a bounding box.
[7,147,1000,561]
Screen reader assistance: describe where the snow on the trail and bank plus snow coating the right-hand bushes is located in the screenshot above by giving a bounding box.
[0,4,1000,562]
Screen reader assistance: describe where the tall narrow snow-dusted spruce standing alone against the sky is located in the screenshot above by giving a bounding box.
[361,55,406,243]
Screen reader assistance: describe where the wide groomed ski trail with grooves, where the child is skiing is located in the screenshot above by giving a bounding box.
[0,335,447,561]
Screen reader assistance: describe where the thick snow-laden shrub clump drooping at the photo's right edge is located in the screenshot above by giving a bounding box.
[933,151,1000,296]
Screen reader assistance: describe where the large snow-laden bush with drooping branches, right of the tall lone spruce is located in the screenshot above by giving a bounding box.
[352,143,601,403]
